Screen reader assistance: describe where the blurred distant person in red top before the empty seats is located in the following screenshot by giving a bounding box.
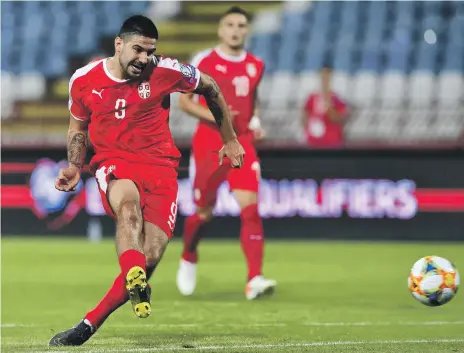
[301,64,350,148]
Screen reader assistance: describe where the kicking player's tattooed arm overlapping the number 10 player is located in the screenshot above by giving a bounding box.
[194,73,245,168]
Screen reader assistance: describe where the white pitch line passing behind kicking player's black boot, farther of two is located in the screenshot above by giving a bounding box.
[0,321,464,328]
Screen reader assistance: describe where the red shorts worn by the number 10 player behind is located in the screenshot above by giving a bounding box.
[190,142,261,207]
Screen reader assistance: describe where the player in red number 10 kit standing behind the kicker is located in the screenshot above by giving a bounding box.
[177,7,276,300]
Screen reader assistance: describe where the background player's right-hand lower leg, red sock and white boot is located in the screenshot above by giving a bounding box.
[233,190,277,300]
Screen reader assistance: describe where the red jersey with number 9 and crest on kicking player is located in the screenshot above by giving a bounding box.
[69,57,200,170]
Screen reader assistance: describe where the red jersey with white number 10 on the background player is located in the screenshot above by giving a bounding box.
[191,48,264,148]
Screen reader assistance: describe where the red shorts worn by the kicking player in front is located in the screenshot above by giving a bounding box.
[95,158,178,238]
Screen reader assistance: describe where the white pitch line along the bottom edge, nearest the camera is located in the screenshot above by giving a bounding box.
[31,338,464,353]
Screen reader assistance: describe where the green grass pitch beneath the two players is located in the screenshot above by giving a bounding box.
[1,237,464,353]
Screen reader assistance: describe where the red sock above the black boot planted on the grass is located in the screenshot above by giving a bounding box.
[85,273,129,328]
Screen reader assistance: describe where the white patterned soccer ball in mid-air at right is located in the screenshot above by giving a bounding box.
[408,256,460,306]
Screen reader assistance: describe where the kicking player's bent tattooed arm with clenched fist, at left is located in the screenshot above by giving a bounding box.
[55,116,88,191]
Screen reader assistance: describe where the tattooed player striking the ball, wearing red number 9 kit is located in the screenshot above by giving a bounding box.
[50,16,244,346]
